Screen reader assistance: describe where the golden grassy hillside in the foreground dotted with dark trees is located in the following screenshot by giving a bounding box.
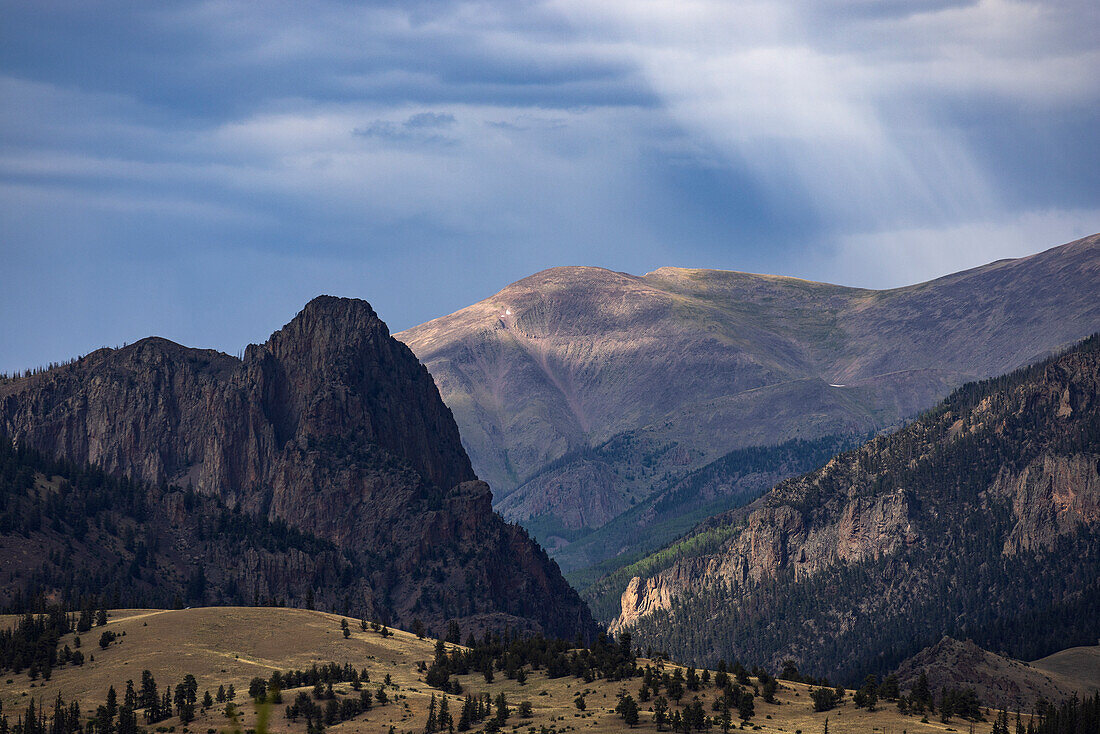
[0,607,1029,734]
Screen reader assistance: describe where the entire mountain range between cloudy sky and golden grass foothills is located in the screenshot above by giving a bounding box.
[0,235,1100,682]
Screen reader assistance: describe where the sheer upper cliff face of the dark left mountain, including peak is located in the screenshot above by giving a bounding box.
[0,296,468,502]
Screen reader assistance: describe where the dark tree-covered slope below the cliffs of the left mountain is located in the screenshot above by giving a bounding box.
[0,438,352,609]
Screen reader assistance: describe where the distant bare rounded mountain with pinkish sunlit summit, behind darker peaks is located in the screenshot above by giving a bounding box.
[396,235,1100,570]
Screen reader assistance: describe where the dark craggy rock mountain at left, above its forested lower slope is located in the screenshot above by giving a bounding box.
[0,296,592,637]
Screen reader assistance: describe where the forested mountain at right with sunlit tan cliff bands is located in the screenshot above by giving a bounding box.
[602,336,1100,680]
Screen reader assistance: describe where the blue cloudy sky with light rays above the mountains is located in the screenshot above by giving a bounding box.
[0,0,1100,371]
